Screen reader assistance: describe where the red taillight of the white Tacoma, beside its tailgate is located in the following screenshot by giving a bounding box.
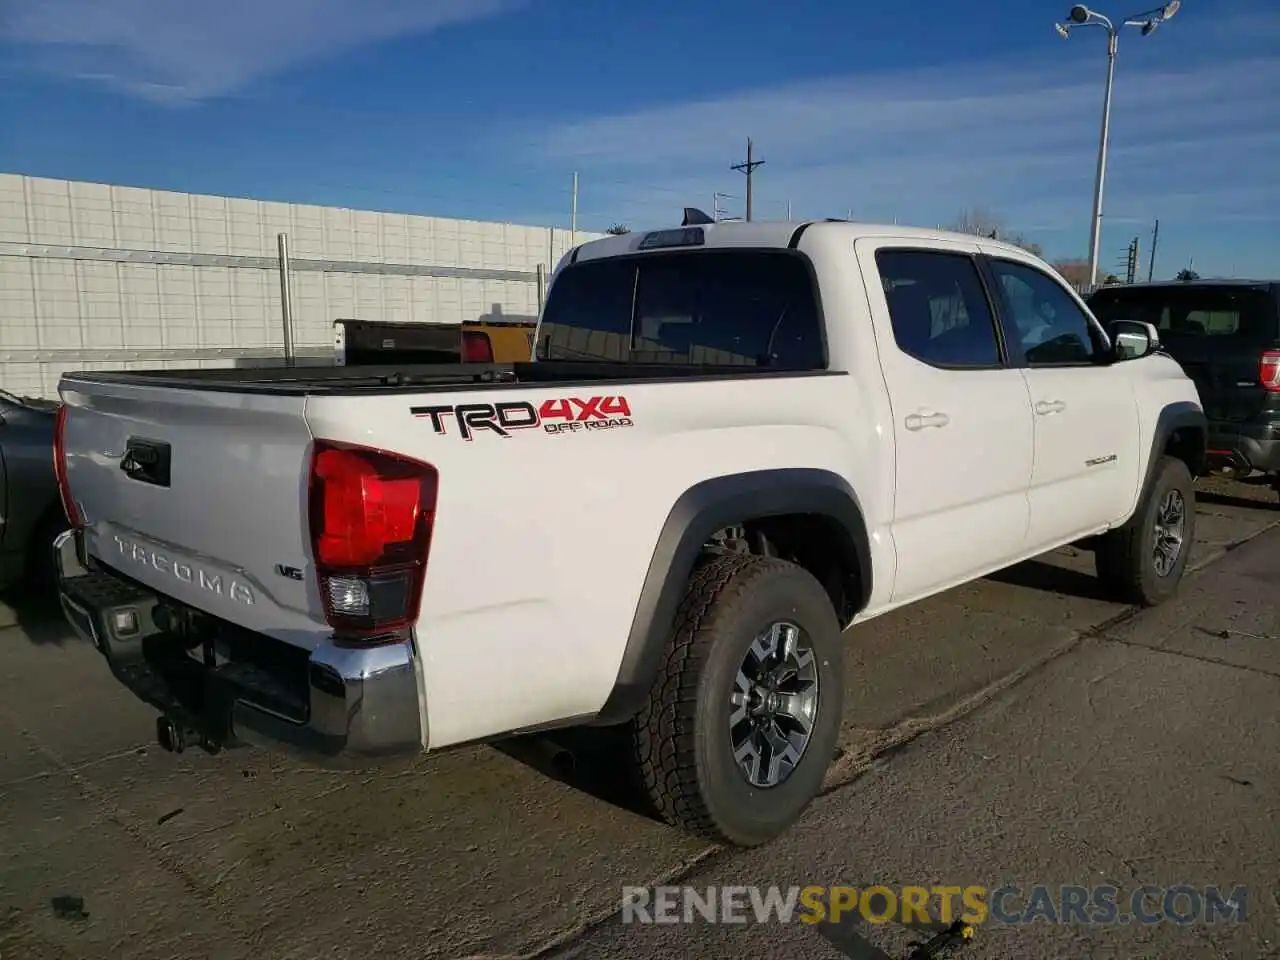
[308,440,438,637]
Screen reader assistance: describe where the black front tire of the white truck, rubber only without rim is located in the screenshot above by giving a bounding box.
[1094,456,1196,607]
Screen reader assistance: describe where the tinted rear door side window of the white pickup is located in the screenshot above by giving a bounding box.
[876,250,1001,369]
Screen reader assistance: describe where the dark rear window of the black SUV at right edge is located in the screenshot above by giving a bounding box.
[1089,285,1280,344]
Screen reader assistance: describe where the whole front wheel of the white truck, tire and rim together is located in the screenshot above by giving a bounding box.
[1094,456,1196,607]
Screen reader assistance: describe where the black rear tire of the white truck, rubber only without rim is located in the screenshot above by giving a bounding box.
[631,554,844,847]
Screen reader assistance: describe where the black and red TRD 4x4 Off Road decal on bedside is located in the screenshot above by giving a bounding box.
[410,397,634,440]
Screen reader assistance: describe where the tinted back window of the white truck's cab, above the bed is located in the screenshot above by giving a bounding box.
[538,251,826,370]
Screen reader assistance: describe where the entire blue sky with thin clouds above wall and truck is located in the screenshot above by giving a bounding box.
[0,0,1280,276]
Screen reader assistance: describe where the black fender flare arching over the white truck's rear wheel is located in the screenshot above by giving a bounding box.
[594,468,873,726]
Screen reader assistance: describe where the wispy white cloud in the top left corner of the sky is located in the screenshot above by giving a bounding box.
[0,0,515,104]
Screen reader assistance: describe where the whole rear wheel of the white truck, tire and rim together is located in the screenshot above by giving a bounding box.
[632,556,844,846]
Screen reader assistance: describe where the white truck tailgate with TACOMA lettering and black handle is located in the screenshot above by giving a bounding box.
[60,376,330,649]
